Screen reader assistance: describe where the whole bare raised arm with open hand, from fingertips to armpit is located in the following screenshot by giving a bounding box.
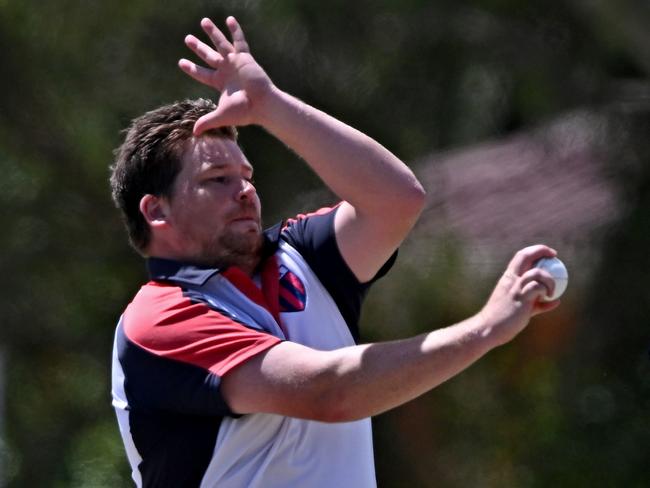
[179,17,425,282]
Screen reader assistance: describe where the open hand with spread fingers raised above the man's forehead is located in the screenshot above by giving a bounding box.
[178,17,273,135]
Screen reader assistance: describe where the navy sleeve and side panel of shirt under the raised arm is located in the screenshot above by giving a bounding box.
[282,209,397,342]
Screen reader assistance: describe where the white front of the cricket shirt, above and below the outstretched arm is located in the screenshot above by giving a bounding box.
[201,242,376,488]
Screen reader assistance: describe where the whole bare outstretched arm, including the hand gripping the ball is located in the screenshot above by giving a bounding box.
[222,246,559,422]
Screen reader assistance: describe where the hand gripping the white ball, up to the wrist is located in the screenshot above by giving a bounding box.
[479,244,560,344]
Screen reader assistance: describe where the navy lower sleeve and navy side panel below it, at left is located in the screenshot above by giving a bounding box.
[117,326,232,488]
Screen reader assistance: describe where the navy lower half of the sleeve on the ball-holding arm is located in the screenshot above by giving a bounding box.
[117,326,232,415]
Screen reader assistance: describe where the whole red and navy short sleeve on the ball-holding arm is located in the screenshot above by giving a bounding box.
[118,284,280,415]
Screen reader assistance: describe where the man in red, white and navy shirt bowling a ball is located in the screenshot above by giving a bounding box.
[111,17,558,488]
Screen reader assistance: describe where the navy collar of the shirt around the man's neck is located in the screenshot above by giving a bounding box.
[146,222,283,286]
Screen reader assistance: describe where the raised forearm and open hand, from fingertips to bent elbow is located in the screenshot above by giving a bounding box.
[179,17,424,215]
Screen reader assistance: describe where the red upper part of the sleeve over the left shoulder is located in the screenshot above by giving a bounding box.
[124,282,280,376]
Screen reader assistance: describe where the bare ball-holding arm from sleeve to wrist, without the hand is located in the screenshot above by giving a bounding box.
[243,317,496,422]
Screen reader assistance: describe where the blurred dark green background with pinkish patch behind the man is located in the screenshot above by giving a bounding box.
[0,0,650,487]
